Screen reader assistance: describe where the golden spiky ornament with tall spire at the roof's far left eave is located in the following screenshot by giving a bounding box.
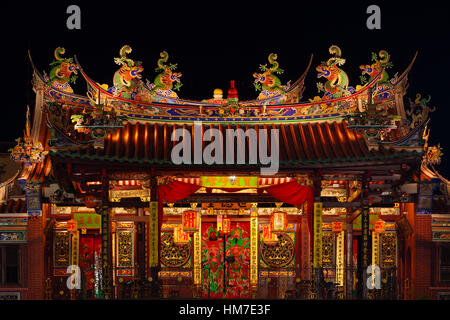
[8,106,48,167]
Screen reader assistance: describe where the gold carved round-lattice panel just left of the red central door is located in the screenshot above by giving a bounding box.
[161,232,191,268]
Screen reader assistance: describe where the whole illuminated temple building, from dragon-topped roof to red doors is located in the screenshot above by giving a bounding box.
[0,46,450,299]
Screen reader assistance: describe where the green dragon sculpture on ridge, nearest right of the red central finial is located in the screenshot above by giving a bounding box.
[253,53,286,100]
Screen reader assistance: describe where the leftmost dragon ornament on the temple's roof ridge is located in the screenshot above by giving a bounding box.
[48,47,78,93]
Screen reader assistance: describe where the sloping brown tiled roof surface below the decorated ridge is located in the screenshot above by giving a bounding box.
[50,122,417,168]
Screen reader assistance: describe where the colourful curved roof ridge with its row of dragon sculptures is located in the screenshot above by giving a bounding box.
[30,46,417,123]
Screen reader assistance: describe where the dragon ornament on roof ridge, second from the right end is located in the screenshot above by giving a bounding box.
[316,45,356,100]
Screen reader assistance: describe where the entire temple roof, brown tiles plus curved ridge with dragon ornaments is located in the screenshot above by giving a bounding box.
[12,46,429,180]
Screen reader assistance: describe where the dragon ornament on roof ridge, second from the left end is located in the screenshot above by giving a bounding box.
[108,45,144,100]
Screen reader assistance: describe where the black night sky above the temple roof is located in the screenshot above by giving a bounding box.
[0,1,450,178]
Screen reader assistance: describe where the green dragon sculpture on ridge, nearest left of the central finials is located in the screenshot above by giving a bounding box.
[148,51,182,98]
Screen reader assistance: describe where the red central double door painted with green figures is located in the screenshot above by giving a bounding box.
[202,222,250,298]
